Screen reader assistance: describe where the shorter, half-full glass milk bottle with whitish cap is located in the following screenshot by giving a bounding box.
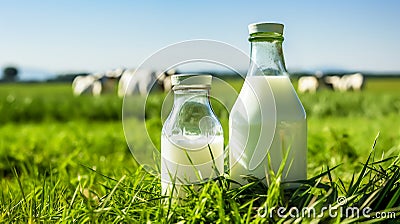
[161,74,224,198]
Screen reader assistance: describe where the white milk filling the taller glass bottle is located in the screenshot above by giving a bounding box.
[229,76,307,184]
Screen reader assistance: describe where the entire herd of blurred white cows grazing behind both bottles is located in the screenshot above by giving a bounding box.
[72,68,364,97]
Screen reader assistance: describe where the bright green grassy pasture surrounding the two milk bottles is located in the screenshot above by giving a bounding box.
[0,78,400,223]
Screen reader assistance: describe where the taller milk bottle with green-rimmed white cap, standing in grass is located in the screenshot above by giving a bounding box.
[229,23,307,187]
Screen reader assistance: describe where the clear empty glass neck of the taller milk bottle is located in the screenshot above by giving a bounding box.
[248,36,287,76]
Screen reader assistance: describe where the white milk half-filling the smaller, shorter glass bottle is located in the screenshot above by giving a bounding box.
[161,135,224,197]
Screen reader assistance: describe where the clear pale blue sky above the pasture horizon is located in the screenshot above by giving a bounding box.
[0,0,400,76]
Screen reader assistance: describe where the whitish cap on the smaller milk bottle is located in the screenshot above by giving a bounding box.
[171,74,212,87]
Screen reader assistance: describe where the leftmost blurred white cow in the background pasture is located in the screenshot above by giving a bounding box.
[72,73,103,96]
